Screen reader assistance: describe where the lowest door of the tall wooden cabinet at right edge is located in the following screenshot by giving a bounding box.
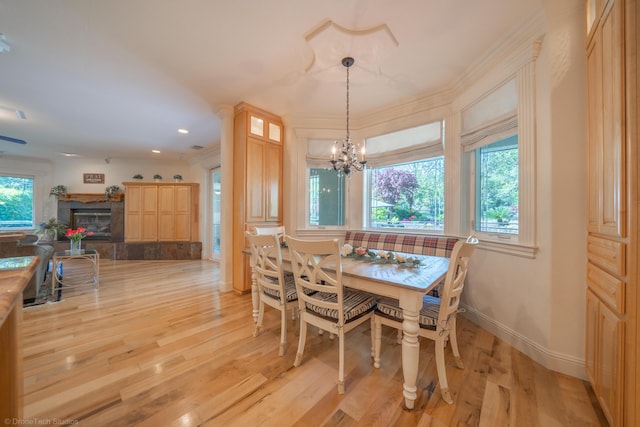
[597,303,624,426]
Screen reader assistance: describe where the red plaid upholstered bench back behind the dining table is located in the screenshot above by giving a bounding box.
[342,231,459,296]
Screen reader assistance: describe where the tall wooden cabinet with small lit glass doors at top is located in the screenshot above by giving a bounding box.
[233,103,283,292]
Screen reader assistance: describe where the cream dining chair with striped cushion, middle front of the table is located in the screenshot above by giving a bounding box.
[287,236,376,394]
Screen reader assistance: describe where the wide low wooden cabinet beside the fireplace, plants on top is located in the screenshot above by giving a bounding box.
[124,182,199,242]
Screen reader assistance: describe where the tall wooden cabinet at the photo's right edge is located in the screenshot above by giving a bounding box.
[585,0,640,426]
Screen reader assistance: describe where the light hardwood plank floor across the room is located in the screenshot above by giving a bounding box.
[23,261,606,427]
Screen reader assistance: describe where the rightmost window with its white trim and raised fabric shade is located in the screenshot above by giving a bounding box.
[460,77,534,245]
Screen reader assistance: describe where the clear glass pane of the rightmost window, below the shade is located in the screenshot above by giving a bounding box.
[474,135,519,234]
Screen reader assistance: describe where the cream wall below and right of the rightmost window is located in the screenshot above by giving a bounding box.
[464,0,586,378]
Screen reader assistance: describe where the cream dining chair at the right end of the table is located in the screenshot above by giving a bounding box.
[373,236,478,404]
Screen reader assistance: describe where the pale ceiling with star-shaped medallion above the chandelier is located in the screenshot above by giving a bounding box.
[0,0,542,159]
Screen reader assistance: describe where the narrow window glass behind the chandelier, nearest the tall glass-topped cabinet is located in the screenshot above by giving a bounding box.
[308,168,345,226]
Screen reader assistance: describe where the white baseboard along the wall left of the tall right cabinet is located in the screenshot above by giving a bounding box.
[460,304,587,380]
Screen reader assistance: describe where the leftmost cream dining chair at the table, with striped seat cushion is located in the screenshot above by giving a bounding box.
[246,232,298,356]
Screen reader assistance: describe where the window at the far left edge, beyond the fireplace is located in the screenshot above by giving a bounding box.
[0,175,34,230]
